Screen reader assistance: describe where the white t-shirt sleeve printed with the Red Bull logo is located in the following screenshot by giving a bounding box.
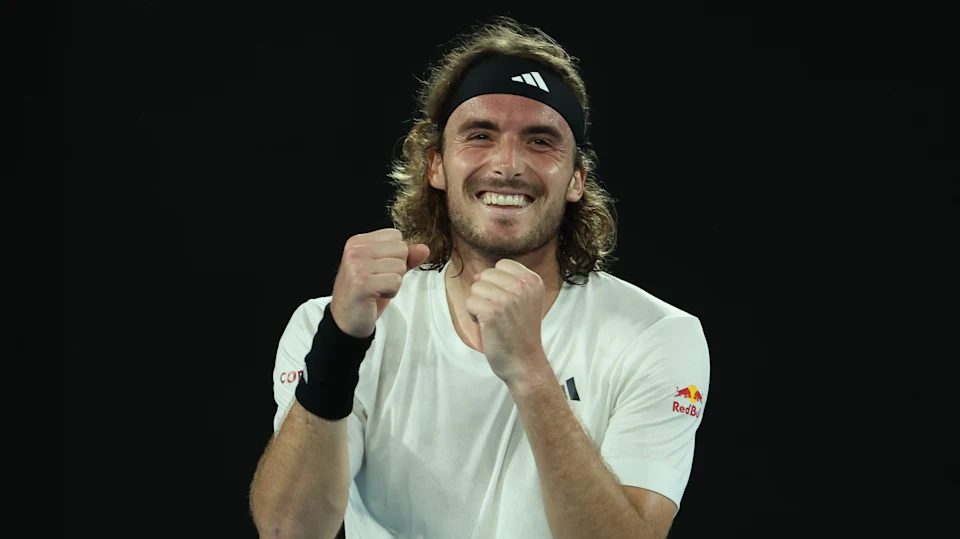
[600,316,710,509]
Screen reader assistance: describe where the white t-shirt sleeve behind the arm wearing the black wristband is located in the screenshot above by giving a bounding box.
[273,297,372,479]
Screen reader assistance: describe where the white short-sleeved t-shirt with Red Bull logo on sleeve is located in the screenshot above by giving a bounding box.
[273,264,710,539]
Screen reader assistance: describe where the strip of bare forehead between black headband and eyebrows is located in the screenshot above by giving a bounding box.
[447,94,573,139]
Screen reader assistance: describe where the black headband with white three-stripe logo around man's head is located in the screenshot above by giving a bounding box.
[440,55,586,146]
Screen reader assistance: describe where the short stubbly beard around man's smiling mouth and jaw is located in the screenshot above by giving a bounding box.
[446,173,566,261]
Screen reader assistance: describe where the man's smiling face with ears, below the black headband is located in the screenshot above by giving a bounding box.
[430,94,585,258]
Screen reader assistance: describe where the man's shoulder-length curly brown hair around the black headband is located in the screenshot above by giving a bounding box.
[388,17,616,284]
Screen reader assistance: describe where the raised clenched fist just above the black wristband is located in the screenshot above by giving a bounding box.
[330,228,430,339]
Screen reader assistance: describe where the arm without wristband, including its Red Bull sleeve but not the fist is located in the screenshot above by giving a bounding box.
[507,317,710,539]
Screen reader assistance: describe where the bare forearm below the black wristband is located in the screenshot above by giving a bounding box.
[250,401,350,538]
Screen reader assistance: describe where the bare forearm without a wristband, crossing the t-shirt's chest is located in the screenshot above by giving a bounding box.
[508,360,658,539]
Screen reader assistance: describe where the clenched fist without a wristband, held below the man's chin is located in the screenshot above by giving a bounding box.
[467,259,543,382]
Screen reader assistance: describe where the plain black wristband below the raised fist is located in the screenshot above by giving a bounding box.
[296,303,376,421]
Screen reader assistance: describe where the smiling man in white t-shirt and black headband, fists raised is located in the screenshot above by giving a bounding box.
[251,19,709,539]
